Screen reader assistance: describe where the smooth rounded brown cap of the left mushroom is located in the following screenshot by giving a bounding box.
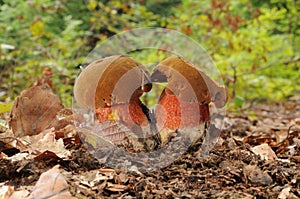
[74,55,152,108]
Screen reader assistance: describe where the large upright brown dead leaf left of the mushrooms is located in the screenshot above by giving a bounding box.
[9,84,64,137]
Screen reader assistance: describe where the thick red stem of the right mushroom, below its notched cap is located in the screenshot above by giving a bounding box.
[155,90,210,130]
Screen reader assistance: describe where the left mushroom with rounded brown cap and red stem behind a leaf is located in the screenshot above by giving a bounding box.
[74,55,152,128]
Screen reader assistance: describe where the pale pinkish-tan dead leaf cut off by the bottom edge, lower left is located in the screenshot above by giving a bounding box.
[27,165,75,199]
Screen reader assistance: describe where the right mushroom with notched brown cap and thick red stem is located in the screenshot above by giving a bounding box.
[151,56,226,143]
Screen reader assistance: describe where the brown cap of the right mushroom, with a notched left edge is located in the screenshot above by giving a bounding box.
[151,56,227,107]
